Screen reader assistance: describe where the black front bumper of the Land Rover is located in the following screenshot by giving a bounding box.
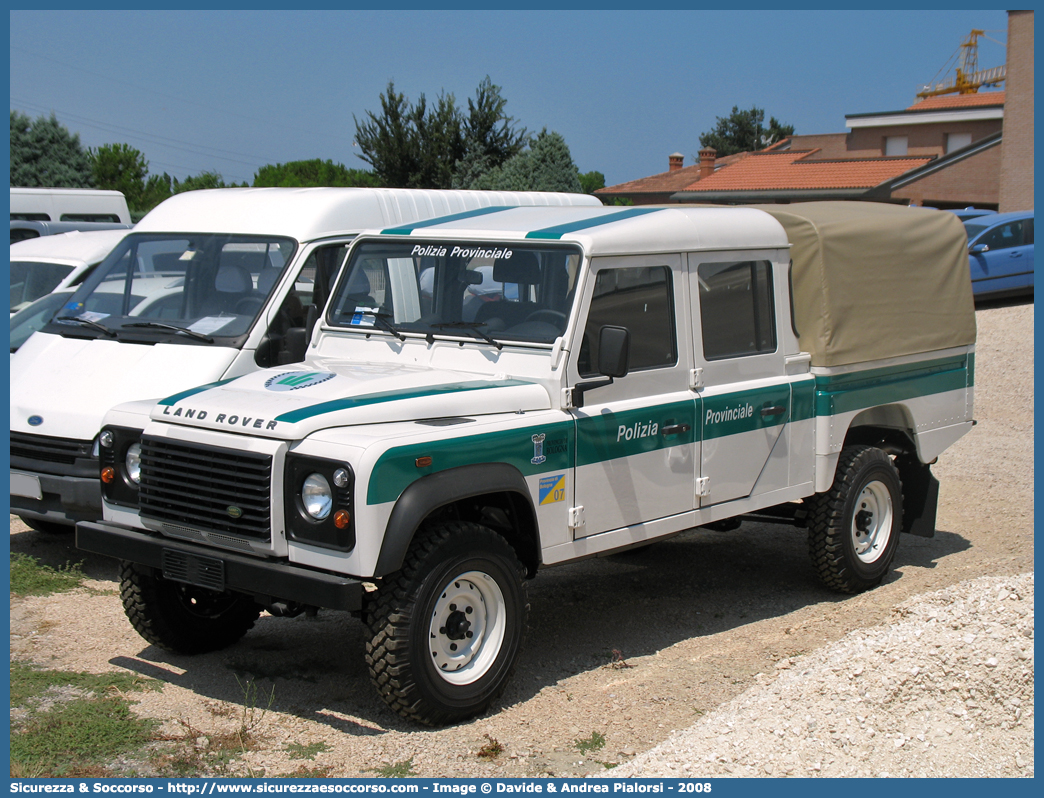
[76,522,364,611]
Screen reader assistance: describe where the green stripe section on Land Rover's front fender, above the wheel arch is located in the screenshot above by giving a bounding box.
[366,421,575,504]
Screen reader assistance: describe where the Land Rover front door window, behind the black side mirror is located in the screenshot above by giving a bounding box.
[577,266,678,377]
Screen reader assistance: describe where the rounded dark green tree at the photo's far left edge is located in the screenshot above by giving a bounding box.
[10,111,94,188]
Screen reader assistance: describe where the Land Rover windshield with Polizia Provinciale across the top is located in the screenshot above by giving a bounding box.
[327,239,580,346]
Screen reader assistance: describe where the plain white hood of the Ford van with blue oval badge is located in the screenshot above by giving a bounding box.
[10,332,239,441]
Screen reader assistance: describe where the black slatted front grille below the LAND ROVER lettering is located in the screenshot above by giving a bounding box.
[139,436,271,541]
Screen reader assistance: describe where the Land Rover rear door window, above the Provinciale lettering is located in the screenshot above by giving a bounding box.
[696,260,776,360]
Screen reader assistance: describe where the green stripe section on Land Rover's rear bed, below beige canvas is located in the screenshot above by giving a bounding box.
[815,355,973,416]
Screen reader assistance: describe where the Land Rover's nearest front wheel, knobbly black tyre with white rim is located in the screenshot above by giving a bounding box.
[364,522,529,726]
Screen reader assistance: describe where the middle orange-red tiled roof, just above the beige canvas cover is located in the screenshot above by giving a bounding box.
[679,149,932,191]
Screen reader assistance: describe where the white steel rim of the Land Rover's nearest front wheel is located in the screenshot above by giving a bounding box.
[428,570,507,685]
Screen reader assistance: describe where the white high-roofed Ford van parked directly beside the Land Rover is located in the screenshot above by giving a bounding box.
[10,188,601,532]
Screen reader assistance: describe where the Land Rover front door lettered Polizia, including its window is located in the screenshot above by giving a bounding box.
[568,255,698,538]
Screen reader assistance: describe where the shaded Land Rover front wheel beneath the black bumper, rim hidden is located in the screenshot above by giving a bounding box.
[120,561,261,654]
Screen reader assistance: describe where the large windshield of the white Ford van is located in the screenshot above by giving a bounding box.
[46,233,296,346]
